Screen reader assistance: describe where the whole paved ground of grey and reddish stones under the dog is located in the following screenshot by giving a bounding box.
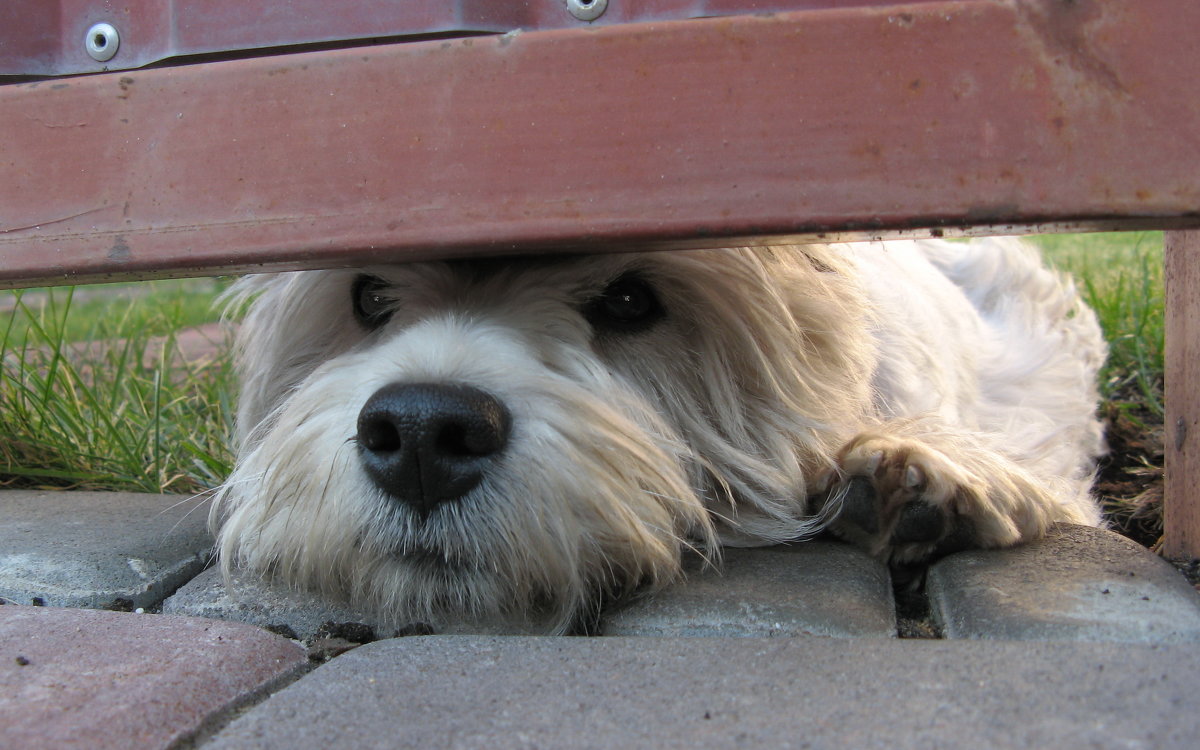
[0,491,1200,750]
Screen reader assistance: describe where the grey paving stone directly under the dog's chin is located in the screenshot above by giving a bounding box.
[162,569,538,638]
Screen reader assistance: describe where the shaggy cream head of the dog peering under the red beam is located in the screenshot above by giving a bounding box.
[214,248,871,629]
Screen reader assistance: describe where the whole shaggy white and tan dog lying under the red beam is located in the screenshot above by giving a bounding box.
[212,240,1105,630]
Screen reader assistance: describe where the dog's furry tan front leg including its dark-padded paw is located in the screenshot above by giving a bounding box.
[823,420,1087,563]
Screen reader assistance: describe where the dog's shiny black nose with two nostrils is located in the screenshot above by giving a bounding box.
[358,383,512,512]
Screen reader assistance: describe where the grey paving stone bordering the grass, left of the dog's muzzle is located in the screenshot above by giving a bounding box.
[0,490,212,607]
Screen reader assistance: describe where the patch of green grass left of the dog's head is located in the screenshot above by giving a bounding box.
[0,280,233,493]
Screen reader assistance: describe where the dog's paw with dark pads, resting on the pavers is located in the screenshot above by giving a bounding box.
[826,434,983,563]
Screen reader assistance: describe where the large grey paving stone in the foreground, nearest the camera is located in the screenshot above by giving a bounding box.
[205,636,1200,750]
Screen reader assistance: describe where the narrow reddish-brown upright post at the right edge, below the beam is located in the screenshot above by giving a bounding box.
[1163,230,1200,559]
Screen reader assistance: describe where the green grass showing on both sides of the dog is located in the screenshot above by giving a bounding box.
[0,233,1163,506]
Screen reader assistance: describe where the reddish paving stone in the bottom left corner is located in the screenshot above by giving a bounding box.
[0,605,307,750]
